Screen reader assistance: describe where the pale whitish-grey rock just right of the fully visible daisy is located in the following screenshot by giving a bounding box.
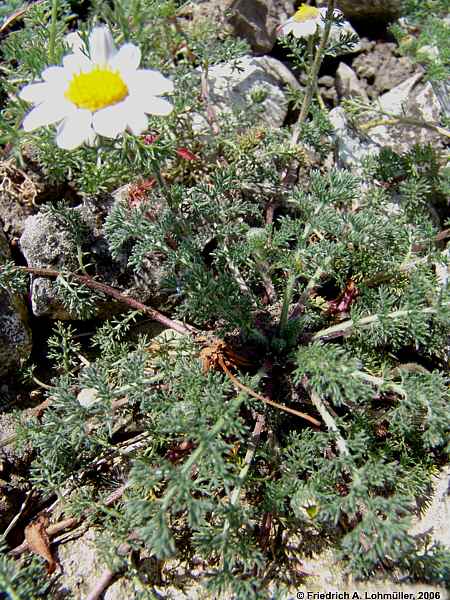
[195,56,300,130]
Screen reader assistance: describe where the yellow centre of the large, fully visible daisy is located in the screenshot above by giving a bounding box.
[64,66,128,111]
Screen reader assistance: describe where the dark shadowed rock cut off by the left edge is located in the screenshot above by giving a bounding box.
[0,230,32,376]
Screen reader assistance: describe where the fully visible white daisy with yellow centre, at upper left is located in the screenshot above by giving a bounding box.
[19,27,173,150]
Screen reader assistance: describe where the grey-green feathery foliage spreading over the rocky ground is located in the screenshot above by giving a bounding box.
[0,0,450,599]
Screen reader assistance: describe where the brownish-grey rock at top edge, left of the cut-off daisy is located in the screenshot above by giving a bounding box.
[229,0,294,54]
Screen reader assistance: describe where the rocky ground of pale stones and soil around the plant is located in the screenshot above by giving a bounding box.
[0,0,450,600]
